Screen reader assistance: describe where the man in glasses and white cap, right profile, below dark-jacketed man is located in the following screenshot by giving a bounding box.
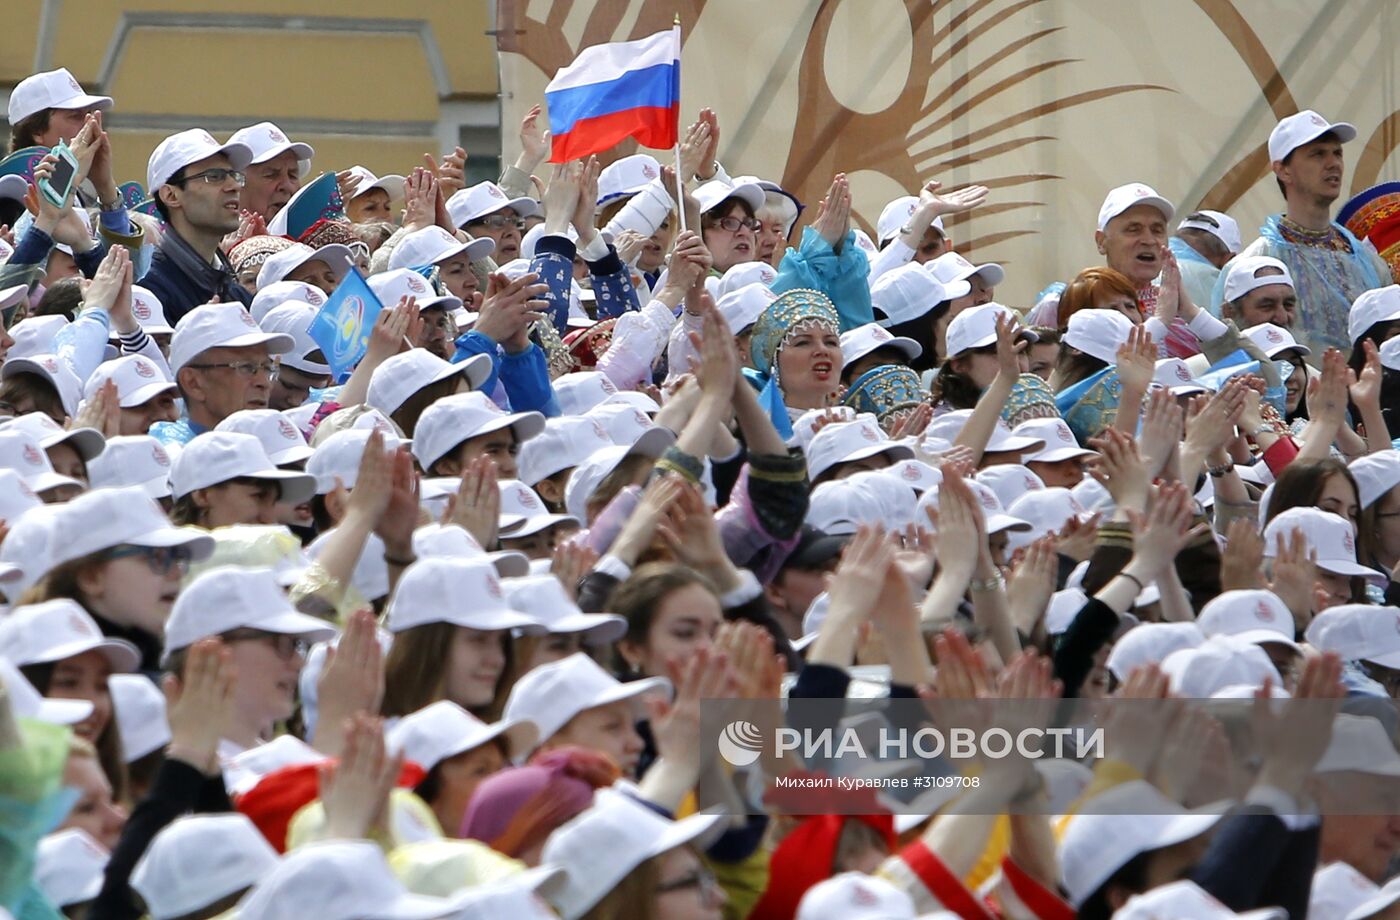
[151,304,295,444]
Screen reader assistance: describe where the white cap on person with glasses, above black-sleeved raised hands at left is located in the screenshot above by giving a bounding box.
[165,566,336,660]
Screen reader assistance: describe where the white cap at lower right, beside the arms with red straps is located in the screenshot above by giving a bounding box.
[1060,780,1221,907]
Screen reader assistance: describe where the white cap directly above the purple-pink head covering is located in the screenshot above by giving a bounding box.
[504,651,671,750]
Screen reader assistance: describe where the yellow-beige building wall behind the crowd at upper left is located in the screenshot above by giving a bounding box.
[0,0,500,190]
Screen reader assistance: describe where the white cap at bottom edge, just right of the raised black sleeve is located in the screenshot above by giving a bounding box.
[132,812,279,920]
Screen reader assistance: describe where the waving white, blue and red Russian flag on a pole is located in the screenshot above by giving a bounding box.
[545,25,680,162]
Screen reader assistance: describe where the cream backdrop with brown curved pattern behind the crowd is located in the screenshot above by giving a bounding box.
[496,0,1400,305]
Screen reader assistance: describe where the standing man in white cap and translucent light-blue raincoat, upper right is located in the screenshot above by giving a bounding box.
[1211,109,1390,353]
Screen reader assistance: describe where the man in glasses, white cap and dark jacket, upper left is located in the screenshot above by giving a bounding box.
[141,127,253,321]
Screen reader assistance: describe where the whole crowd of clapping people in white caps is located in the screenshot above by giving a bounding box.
[0,59,1400,920]
